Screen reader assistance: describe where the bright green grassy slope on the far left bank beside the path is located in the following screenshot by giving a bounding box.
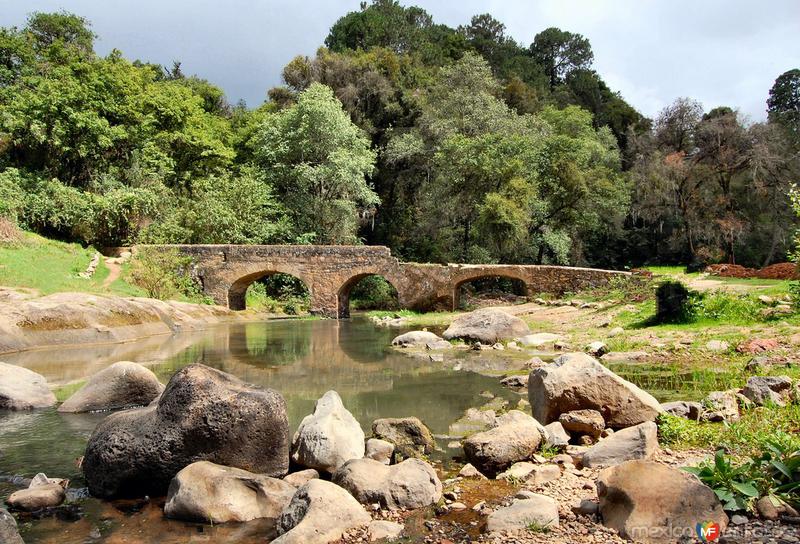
[0,233,144,296]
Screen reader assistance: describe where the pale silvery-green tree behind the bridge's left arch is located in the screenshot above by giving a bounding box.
[255,83,379,243]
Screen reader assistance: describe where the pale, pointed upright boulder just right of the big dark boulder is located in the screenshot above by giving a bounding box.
[292,391,364,473]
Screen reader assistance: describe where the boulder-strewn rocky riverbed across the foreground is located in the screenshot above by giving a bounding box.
[0,304,800,544]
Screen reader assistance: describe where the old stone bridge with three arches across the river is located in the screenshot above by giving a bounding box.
[153,245,628,317]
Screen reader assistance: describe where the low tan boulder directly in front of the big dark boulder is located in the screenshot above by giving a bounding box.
[164,461,296,523]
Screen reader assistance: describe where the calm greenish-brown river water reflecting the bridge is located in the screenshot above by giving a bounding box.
[0,318,519,544]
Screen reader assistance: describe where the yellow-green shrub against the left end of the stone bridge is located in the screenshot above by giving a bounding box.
[130,247,203,303]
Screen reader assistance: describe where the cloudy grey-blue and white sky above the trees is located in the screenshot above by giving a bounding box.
[0,0,800,121]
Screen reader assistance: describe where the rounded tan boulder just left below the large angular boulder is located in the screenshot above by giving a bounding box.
[464,410,542,477]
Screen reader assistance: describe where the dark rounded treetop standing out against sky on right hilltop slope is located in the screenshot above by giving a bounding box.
[530,27,594,89]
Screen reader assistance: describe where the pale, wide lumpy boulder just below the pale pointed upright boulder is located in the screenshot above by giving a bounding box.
[332,459,442,510]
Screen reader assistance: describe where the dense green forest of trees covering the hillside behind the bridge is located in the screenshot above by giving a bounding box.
[0,0,800,267]
